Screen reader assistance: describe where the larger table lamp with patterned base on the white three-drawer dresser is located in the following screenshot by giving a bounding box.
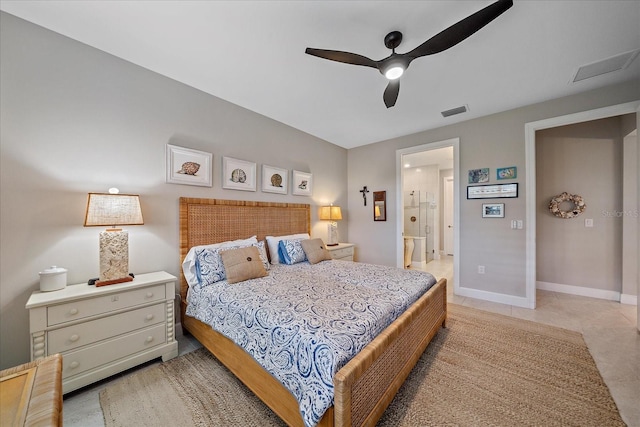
[84,188,144,286]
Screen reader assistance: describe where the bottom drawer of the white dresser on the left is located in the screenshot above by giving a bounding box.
[62,324,167,380]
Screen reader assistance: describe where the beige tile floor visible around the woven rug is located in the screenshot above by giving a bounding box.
[64,257,640,427]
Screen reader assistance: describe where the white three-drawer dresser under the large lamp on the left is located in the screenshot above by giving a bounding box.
[26,271,178,393]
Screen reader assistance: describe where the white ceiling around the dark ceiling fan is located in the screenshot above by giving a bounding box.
[0,0,640,148]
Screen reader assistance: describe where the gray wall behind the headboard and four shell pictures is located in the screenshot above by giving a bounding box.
[0,13,349,368]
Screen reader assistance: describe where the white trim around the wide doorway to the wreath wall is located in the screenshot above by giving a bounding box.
[524,101,640,310]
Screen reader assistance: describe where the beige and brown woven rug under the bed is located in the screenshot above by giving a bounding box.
[100,304,625,427]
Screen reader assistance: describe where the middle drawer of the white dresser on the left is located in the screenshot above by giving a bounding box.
[47,303,166,354]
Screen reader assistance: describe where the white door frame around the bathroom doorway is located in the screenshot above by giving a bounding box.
[396,138,460,289]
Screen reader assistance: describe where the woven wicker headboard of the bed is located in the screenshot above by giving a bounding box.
[180,197,311,305]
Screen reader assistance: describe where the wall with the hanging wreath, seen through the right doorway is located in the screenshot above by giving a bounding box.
[536,117,623,292]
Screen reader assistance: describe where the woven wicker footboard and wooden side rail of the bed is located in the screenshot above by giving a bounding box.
[183,279,447,427]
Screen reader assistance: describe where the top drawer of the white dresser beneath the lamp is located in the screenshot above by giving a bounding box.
[47,284,165,326]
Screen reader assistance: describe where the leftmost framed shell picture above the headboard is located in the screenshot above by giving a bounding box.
[165,144,213,187]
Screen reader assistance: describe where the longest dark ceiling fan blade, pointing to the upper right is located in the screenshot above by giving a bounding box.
[405,0,513,59]
